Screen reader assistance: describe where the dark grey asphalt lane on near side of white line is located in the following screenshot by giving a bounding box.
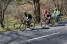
[23,31,67,44]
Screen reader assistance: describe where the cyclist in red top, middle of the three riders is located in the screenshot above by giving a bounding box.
[42,9,50,27]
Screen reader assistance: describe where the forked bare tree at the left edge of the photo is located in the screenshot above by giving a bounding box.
[0,0,13,28]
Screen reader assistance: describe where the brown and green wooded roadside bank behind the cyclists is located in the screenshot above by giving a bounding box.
[0,0,67,32]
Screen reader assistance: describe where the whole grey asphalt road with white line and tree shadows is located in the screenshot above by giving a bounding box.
[0,26,67,44]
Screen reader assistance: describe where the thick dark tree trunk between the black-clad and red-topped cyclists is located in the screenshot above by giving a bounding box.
[33,0,40,22]
